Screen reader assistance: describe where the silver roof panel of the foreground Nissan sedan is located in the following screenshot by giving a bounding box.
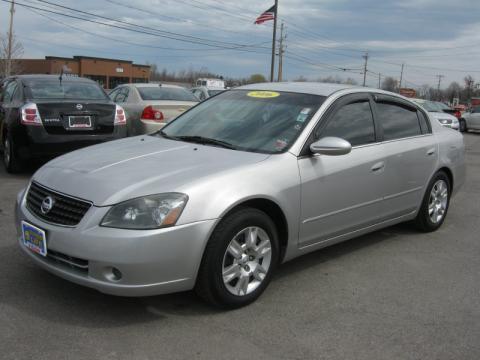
[237,82,358,96]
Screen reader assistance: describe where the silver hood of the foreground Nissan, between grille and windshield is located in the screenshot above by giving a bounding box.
[33,136,269,206]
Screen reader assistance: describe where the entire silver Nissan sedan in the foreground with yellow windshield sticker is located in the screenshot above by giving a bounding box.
[16,83,465,308]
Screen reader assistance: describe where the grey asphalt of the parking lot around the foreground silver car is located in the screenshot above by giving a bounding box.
[0,133,480,360]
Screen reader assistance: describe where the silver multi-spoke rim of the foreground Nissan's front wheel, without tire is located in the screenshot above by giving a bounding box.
[222,226,272,296]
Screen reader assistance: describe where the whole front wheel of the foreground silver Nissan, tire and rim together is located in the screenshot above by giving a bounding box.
[196,208,279,308]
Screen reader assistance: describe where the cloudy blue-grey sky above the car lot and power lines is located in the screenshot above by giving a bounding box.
[0,0,480,88]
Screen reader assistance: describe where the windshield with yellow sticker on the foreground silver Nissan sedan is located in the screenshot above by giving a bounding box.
[159,90,325,154]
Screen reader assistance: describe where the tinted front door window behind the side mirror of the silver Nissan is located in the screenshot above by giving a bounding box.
[316,100,375,146]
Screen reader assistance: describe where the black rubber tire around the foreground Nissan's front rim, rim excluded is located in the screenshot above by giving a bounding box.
[195,207,279,309]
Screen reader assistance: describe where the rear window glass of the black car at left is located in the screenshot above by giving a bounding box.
[26,79,108,100]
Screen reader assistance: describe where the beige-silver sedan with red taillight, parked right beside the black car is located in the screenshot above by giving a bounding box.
[109,83,198,136]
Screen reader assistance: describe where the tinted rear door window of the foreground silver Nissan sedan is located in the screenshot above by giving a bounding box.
[376,102,422,140]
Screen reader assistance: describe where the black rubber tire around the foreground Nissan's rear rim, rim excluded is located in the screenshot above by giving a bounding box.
[414,171,452,232]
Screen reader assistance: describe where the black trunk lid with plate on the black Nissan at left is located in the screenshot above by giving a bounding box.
[35,101,115,135]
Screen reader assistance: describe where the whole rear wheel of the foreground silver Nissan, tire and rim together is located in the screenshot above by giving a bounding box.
[415,171,451,232]
